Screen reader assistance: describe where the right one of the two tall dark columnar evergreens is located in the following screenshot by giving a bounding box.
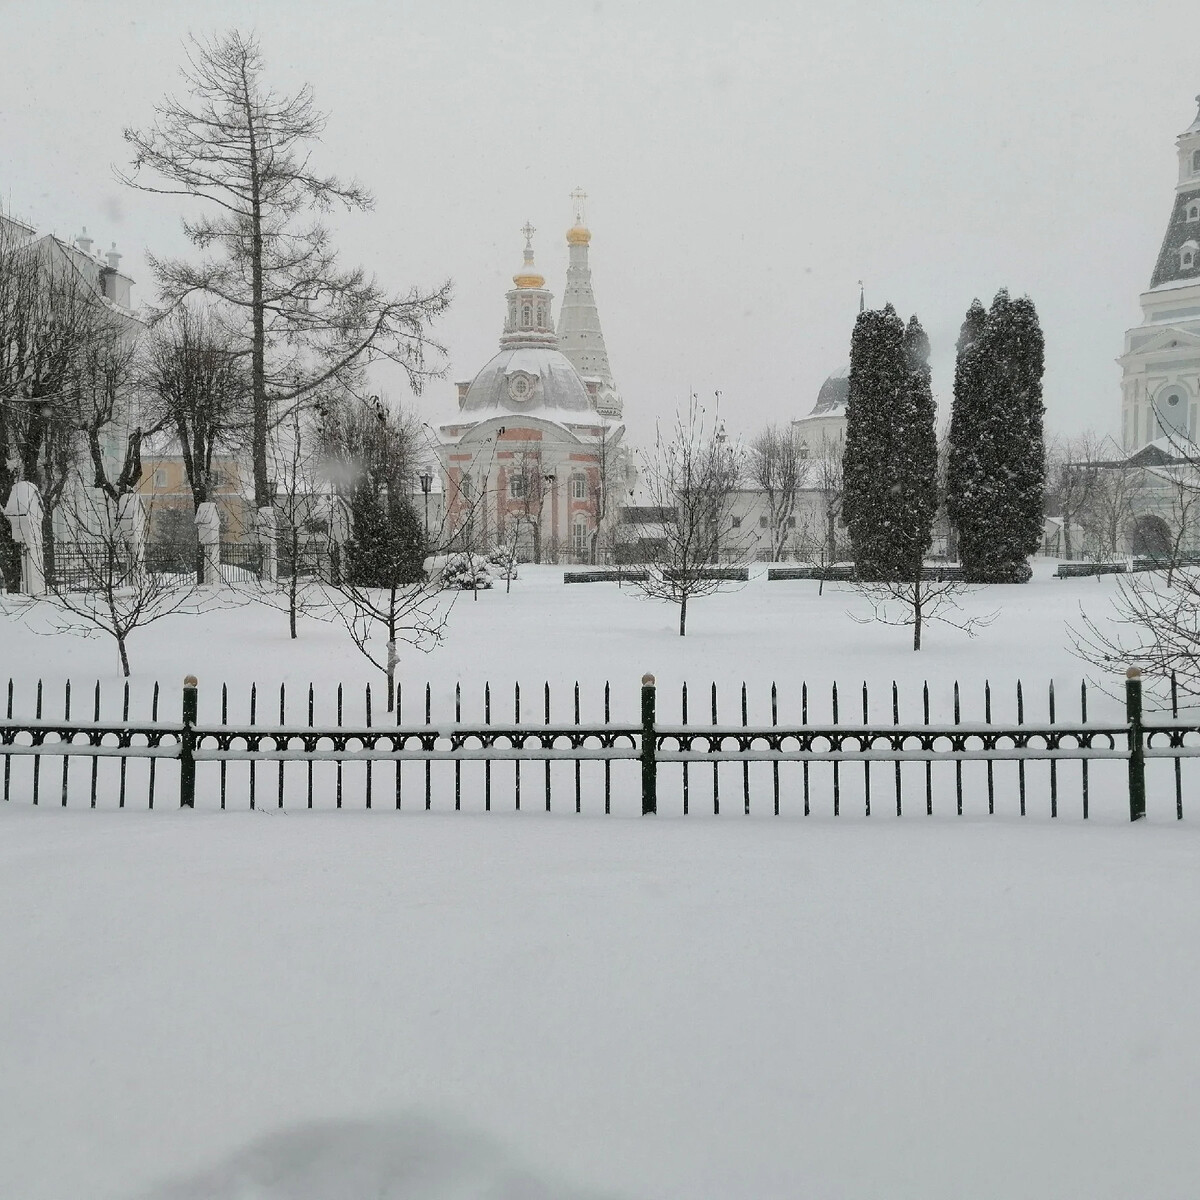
[947,289,1045,583]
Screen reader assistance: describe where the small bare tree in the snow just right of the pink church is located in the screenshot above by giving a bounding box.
[635,397,744,637]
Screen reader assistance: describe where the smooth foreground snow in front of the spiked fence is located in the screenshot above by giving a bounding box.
[0,805,1200,1200]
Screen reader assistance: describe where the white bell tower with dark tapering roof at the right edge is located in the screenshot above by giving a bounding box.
[1117,96,1200,454]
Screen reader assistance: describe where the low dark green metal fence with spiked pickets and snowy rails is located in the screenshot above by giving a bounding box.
[0,671,1200,821]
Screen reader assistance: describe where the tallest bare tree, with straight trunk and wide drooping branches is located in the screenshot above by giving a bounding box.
[118,30,450,509]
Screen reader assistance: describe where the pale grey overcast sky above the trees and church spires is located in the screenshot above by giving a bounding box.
[0,0,1200,446]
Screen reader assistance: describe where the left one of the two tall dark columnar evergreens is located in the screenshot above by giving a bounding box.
[842,305,937,582]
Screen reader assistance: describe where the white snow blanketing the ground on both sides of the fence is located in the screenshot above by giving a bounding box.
[0,563,1200,1200]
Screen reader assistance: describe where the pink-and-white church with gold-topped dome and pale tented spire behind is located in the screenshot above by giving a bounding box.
[438,199,628,563]
